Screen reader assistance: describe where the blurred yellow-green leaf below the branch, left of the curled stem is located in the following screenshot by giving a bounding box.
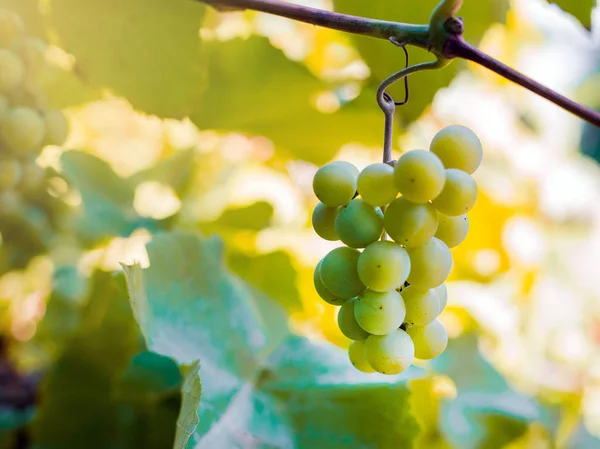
[190,36,383,164]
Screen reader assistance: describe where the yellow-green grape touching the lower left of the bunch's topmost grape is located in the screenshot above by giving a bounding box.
[394,150,446,203]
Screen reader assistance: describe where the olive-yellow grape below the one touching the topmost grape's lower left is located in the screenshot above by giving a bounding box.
[383,197,437,248]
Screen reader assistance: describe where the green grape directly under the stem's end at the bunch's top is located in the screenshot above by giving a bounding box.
[358,162,398,206]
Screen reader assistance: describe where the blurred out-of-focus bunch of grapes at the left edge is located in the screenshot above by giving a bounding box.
[0,8,68,271]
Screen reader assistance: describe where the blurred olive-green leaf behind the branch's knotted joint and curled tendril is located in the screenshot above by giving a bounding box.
[334,0,509,126]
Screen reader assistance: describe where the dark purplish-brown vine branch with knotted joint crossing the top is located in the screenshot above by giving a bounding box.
[196,0,600,128]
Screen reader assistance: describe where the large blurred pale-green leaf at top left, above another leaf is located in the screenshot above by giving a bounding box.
[52,0,205,118]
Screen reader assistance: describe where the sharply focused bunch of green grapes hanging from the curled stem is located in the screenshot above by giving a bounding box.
[312,126,483,374]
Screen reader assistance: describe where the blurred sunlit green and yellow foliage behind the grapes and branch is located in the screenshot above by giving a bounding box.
[0,0,600,449]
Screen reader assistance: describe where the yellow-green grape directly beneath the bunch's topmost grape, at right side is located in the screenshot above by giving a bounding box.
[433,168,477,217]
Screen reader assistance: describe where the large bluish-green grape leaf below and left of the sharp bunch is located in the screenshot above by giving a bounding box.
[126,231,421,448]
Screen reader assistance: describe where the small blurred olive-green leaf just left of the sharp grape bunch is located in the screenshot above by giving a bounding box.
[228,251,302,311]
